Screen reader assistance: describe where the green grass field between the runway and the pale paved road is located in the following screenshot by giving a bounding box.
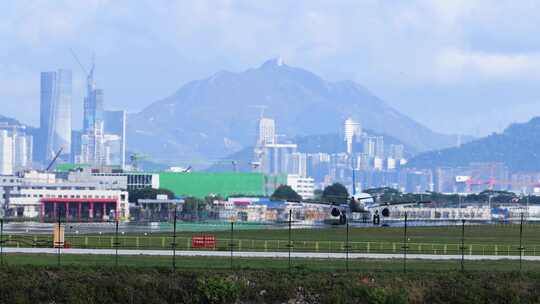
[4,224,540,255]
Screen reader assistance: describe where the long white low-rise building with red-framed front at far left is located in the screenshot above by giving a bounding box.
[0,171,129,221]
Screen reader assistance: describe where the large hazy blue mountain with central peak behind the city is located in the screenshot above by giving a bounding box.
[128,59,457,164]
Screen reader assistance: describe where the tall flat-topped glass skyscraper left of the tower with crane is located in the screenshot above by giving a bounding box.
[40,69,72,161]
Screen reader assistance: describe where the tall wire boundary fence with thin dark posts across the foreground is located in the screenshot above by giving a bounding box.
[0,216,540,271]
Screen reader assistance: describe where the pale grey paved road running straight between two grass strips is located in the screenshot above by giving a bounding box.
[4,247,540,261]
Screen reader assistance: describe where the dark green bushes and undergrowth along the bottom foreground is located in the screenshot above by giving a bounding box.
[0,266,540,304]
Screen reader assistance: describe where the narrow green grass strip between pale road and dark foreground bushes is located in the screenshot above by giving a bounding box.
[3,254,540,273]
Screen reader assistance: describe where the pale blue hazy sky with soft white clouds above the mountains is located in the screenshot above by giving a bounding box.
[0,0,540,135]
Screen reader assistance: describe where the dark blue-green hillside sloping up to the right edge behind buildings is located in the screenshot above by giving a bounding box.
[408,117,540,171]
